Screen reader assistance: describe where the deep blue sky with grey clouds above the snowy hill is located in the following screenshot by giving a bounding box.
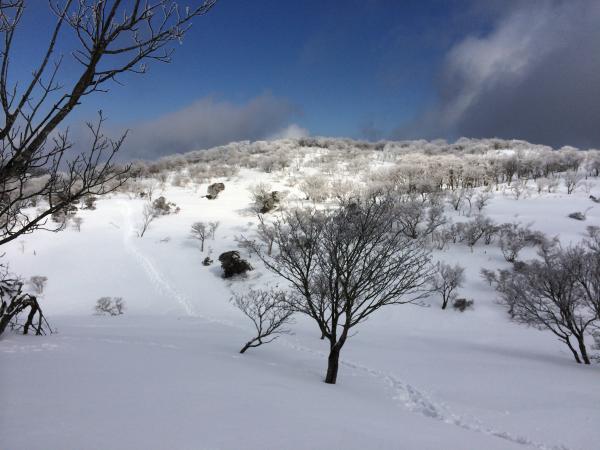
[8,0,600,157]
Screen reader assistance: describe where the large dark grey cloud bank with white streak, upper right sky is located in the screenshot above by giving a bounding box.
[396,0,600,147]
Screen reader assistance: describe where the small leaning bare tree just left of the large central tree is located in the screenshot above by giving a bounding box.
[232,289,293,353]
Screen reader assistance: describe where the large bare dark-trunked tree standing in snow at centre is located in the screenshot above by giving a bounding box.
[244,196,429,384]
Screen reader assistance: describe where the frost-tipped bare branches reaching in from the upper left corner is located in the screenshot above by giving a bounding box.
[0,0,216,245]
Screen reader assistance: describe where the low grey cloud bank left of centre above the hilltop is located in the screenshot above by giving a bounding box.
[117,94,307,159]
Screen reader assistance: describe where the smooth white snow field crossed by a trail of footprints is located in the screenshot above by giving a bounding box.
[0,159,600,450]
